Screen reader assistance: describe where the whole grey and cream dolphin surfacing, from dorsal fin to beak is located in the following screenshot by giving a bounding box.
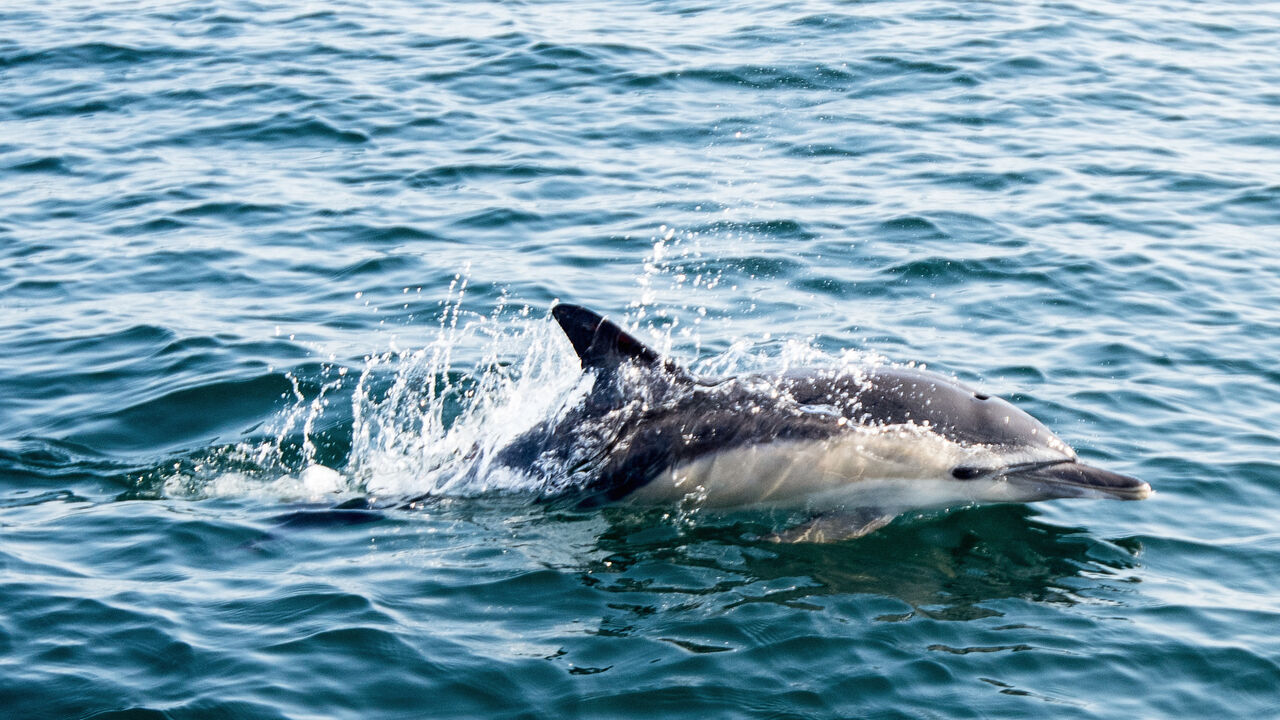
[493,304,1151,541]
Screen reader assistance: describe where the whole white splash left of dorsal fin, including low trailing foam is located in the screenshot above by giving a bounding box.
[152,280,590,501]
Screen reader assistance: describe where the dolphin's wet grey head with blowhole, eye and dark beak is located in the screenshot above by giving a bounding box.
[786,366,1151,502]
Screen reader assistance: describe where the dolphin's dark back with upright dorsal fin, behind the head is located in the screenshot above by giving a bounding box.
[495,304,840,505]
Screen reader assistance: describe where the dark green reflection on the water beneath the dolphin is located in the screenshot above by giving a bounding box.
[570,505,1142,621]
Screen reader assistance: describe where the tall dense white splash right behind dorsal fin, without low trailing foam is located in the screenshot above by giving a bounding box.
[346,299,586,496]
